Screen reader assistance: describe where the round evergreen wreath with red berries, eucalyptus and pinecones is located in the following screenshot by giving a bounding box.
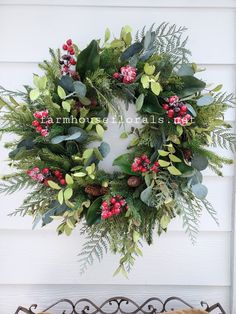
[0,23,236,274]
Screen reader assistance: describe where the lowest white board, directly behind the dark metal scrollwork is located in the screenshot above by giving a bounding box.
[0,284,230,314]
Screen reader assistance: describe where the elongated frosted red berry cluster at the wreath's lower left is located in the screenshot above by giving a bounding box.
[27,167,66,186]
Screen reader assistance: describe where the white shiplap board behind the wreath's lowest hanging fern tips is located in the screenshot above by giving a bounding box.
[0,230,230,286]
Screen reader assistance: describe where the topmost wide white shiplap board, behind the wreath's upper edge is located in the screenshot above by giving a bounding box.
[0,5,236,64]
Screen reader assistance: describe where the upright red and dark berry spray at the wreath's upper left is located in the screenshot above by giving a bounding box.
[60,39,76,74]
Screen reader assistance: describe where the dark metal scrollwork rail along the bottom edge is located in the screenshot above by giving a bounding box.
[15,297,226,314]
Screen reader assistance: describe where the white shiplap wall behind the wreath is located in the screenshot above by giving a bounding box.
[0,0,236,314]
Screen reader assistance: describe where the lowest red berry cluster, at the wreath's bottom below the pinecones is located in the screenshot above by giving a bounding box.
[101,195,128,219]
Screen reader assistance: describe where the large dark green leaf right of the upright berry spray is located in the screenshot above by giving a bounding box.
[76,40,100,77]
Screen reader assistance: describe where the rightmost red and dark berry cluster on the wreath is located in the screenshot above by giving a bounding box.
[162,96,191,125]
